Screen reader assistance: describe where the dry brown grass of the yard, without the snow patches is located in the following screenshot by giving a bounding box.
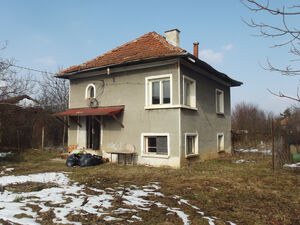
[0,150,300,225]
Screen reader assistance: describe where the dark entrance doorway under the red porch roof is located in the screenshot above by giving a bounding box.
[86,116,101,150]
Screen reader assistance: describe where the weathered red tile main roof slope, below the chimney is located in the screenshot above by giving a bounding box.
[57,32,186,75]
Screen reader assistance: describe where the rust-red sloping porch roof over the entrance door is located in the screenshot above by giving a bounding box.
[52,106,124,116]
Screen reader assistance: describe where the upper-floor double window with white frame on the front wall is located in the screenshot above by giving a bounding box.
[146,75,172,106]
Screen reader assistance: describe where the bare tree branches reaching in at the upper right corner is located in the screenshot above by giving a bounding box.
[240,0,300,102]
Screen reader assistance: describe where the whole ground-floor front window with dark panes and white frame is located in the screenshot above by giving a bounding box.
[142,134,169,155]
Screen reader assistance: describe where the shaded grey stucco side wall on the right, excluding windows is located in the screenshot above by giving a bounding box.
[181,66,231,160]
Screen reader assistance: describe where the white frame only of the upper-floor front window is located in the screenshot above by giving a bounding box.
[145,74,173,108]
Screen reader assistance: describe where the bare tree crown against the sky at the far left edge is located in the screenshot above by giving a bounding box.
[0,43,34,101]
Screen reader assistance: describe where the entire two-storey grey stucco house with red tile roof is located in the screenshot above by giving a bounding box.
[55,29,242,167]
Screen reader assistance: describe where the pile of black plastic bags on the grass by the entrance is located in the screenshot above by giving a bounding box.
[66,153,103,167]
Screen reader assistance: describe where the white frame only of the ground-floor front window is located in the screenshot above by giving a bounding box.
[141,133,170,158]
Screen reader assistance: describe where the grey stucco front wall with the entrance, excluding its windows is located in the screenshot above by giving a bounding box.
[69,64,180,167]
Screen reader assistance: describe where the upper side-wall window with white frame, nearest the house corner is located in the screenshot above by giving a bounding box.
[183,76,196,107]
